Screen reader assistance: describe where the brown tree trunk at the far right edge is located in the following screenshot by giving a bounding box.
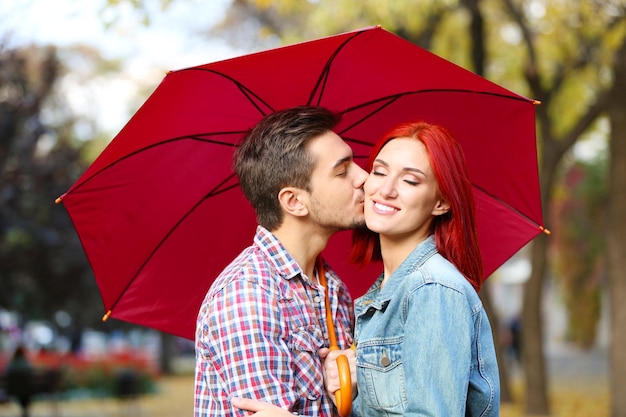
[606,38,626,417]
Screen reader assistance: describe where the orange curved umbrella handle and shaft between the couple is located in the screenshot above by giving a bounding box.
[317,256,352,417]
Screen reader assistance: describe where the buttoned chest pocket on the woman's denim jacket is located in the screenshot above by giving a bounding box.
[357,340,407,414]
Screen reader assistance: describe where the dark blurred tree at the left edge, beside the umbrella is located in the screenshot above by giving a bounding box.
[0,45,105,334]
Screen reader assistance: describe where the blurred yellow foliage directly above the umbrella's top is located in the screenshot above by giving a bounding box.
[213,0,454,51]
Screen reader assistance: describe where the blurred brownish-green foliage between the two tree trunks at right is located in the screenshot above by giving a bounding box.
[550,161,608,349]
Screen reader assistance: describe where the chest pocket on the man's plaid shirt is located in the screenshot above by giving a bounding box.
[289,326,324,401]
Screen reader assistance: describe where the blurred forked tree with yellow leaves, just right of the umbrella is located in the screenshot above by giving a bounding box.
[502,0,626,415]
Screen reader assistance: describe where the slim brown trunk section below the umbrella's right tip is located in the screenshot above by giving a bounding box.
[522,234,550,416]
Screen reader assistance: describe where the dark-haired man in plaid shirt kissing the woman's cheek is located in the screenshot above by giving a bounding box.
[195,107,367,417]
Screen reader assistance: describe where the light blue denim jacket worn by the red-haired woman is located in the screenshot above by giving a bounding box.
[353,236,500,417]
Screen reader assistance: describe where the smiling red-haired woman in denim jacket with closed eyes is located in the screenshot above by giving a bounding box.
[234,122,500,417]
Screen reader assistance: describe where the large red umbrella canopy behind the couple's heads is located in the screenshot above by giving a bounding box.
[60,27,543,339]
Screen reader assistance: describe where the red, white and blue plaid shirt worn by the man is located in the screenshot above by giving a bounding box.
[194,226,354,417]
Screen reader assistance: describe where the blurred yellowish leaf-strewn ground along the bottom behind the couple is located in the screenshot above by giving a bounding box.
[0,375,610,417]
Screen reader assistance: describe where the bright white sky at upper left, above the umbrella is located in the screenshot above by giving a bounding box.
[0,0,244,132]
